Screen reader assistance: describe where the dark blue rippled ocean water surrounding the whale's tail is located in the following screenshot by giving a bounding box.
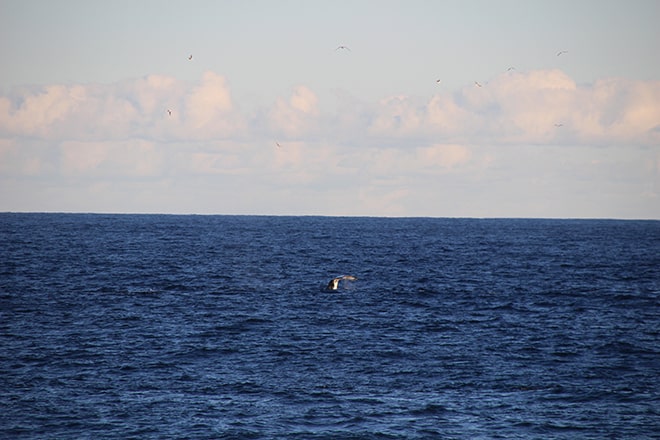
[0,213,660,439]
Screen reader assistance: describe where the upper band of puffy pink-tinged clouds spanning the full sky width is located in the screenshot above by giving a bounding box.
[0,70,660,145]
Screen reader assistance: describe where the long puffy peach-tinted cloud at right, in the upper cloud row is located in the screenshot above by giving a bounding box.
[368,70,660,145]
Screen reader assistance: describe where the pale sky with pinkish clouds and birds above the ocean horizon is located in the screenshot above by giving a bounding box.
[0,0,660,219]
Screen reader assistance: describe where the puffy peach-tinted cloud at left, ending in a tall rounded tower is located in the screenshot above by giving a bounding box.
[0,72,246,141]
